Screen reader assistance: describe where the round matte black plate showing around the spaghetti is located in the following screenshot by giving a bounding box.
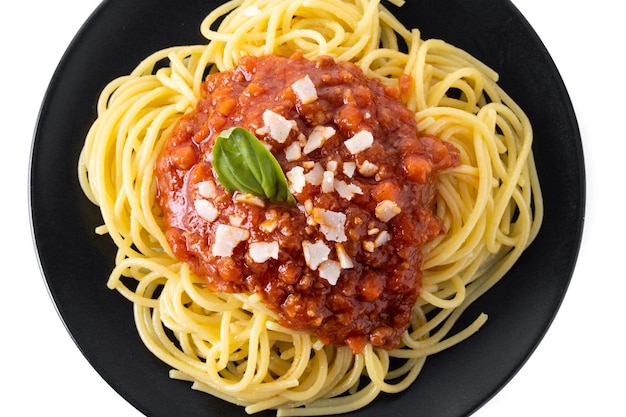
[30,0,585,417]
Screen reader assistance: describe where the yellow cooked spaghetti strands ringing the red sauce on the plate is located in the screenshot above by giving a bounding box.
[79,0,543,416]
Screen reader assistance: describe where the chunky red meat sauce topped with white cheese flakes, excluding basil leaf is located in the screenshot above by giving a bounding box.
[155,54,459,353]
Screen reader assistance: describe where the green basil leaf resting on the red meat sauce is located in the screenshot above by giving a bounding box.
[213,127,296,204]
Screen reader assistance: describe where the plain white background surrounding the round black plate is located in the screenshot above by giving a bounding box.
[0,0,626,417]
